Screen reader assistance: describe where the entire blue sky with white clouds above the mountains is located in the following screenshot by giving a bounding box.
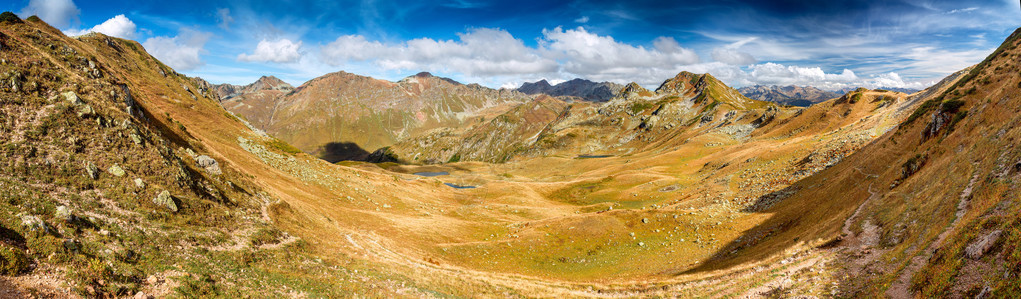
[7,0,1021,89]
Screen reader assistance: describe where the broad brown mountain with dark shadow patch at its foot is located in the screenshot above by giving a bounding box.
[204,71,533,161]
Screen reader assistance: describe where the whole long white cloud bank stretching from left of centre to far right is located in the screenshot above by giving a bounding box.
[314,28,935,90]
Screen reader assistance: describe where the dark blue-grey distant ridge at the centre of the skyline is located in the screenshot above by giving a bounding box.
[517,79,624,102]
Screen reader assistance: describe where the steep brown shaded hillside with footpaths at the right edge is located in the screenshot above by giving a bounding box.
[686,27,1021,297]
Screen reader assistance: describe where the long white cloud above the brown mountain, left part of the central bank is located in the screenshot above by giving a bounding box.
[321,29,556,77]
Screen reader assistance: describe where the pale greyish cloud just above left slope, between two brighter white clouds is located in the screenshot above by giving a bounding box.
[142,29,212,70]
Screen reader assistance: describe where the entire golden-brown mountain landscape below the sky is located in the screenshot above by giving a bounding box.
[0,12,1021,298]
